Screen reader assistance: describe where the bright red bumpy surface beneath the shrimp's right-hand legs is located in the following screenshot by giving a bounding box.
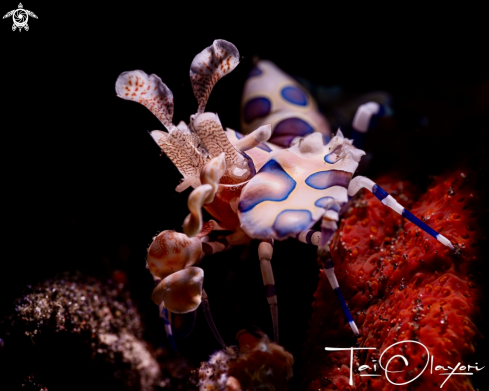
[303,170,484,391]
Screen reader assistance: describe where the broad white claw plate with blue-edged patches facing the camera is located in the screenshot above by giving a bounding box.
[238,132,364,240]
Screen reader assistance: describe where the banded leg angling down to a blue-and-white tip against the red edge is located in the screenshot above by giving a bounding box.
[318,209,360,335]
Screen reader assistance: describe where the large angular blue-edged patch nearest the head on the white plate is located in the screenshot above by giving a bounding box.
[238,159,297,213]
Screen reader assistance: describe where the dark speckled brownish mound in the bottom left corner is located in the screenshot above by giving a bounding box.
[0,274,188,391]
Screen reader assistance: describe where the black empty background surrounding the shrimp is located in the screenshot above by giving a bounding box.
[0,1,489,388]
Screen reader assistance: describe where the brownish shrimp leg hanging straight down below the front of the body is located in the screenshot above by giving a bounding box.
[258,239,278,343]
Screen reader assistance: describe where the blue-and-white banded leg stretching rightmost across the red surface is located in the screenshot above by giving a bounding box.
[348,176,454,250]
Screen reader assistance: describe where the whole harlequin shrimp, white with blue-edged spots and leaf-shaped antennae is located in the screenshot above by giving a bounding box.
[116,40,453,347]
